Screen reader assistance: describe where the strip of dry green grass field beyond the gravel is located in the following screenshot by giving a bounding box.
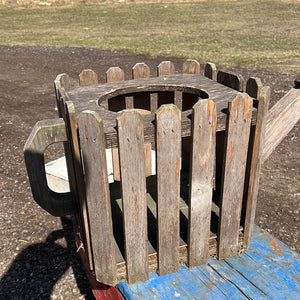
[0,0,300,73]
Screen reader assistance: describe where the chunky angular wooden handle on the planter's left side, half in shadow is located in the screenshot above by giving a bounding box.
[23,119,77,216]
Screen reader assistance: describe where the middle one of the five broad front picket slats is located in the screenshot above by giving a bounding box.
[156,105,181,275]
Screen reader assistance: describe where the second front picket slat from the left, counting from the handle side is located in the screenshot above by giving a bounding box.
[117,110,148,283]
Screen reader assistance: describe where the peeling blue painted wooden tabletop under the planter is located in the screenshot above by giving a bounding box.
[117,226,300,300]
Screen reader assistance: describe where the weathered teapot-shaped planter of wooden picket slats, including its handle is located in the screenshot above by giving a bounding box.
[25,60,299,285]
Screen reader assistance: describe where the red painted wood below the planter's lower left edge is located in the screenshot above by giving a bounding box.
[74,227,125,300]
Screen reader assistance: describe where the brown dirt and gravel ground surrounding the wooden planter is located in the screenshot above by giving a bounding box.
[0,47,300,299]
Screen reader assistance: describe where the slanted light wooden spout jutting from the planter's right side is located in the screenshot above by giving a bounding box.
[262,87,300,162]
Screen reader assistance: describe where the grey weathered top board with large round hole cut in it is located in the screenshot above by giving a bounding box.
[67,75,247,148]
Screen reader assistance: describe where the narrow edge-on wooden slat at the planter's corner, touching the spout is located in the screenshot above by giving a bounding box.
[244,87,270,249]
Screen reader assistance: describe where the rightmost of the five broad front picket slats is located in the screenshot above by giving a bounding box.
[218,94,252,259]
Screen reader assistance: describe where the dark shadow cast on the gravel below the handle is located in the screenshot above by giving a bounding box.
[0,218,94,299]
